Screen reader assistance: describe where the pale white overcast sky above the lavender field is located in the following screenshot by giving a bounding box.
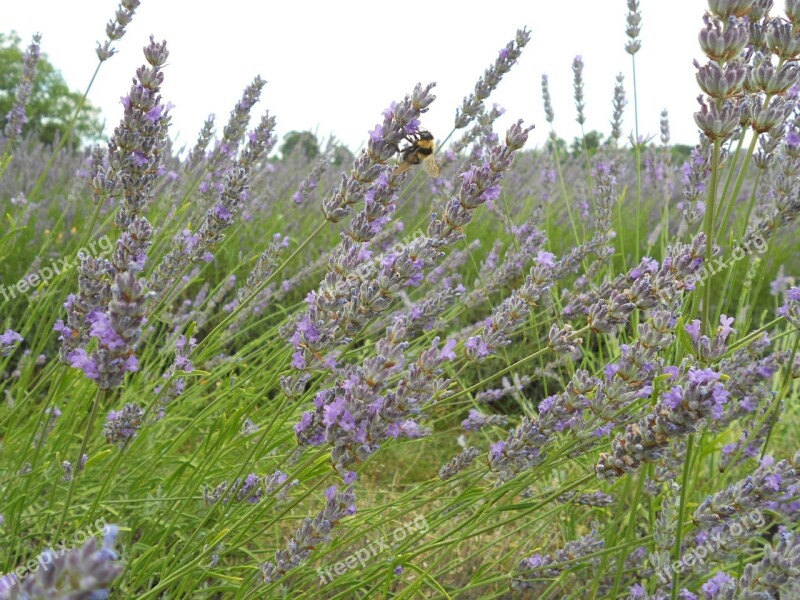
[0,0,706,155]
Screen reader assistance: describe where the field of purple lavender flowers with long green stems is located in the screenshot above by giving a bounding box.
[0,0,800,600]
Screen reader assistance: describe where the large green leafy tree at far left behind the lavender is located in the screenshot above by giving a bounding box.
[0,32,103,148]
